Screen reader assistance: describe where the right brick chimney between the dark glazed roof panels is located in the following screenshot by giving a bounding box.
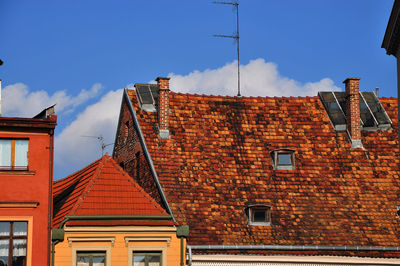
[343,78,363,148]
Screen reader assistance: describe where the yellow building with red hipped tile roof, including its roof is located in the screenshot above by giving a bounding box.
[52,155,189,266]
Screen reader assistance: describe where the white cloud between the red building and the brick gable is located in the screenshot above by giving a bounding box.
[55,89,123,179]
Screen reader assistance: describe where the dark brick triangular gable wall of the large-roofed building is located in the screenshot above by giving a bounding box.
[114,97,164,206]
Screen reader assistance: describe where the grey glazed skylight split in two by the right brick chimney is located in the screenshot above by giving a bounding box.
[318,91,392,131]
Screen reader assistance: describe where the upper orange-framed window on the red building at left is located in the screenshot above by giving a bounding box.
[0,139,28,170]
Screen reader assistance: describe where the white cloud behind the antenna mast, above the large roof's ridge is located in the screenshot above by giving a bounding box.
[168,58,341,96]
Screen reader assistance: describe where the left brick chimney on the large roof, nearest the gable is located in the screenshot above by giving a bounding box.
[156,77,169,139]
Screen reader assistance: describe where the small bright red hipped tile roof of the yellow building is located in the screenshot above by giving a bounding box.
[53,155,172,227]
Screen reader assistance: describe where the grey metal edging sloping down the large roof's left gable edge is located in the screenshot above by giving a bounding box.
[121,89,176,223]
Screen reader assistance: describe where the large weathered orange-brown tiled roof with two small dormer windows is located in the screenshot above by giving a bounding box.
[128,90,400,246]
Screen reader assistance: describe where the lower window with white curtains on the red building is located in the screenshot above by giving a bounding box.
[0,221,28,266]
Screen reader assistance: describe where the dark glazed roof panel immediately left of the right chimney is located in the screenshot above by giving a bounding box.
[318,91,346,131]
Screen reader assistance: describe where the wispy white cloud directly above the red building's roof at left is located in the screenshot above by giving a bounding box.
[2,83,102,117]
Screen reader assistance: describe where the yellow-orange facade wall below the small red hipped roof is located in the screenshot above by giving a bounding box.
[54,223,186,266]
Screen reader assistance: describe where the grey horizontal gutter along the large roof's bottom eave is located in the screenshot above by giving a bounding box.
[187,245,400,266]
